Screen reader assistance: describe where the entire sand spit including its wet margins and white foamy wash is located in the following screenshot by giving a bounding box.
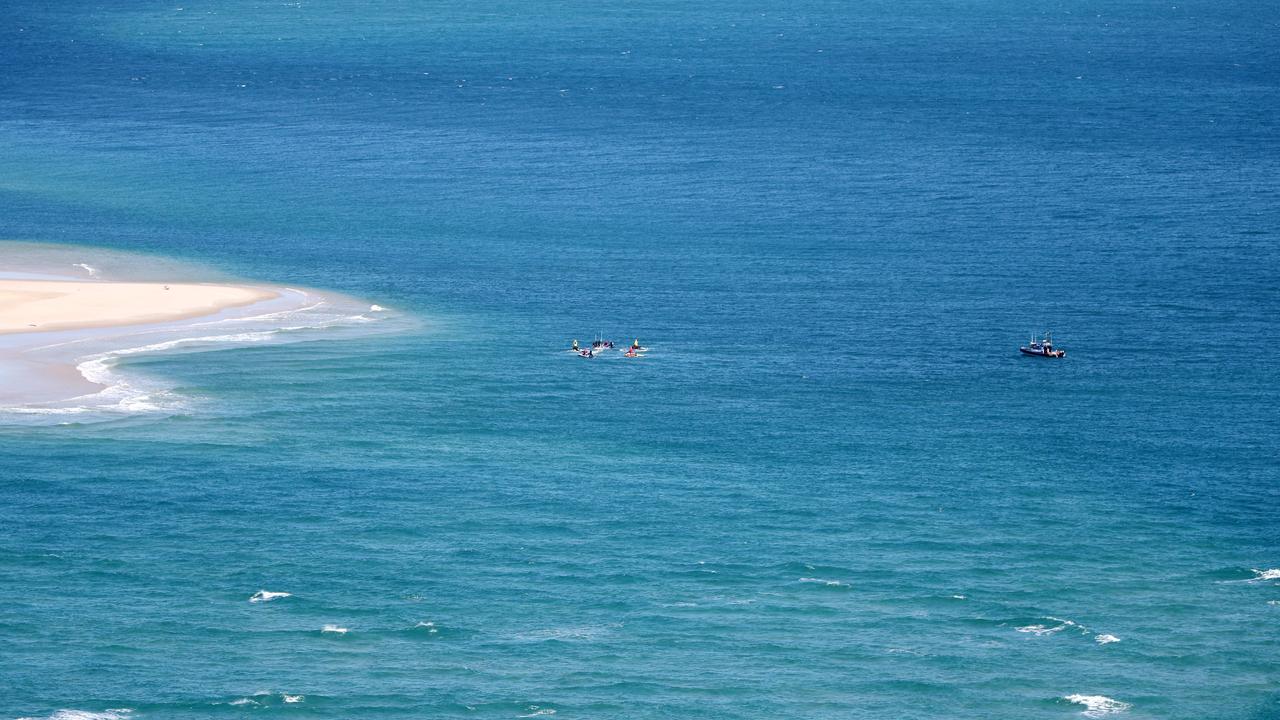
[0,242,415,423]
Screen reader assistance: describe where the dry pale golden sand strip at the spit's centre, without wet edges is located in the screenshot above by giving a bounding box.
[0,279,279,334]
